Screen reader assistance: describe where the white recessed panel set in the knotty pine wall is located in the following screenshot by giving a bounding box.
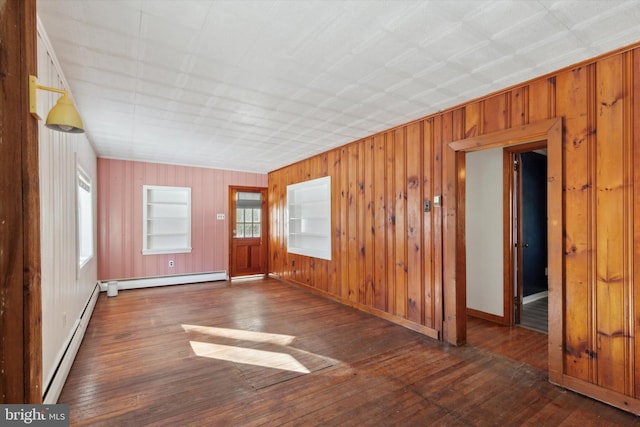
[287,176,331,260]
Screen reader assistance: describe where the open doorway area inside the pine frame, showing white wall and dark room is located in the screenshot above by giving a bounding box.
[465,140,548,333]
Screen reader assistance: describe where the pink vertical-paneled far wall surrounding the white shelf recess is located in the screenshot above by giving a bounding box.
[98,159,267,280]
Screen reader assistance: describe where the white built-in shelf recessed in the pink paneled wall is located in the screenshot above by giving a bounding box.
[142,185,191,255]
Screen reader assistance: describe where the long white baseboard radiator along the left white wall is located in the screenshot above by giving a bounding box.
[42,283,100,405]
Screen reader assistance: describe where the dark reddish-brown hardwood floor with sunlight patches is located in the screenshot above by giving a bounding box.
[59,279,640,426]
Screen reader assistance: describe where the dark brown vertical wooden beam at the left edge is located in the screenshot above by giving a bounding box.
[0,0,42,404]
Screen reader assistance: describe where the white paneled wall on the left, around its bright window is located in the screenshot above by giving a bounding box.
[37,22,98,402]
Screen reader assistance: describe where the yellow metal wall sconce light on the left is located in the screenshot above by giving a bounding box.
[29,76,84,133]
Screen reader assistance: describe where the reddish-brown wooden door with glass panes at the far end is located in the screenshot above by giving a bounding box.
[229,187,268,278]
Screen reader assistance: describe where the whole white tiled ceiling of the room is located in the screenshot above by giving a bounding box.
[37,0,640,172]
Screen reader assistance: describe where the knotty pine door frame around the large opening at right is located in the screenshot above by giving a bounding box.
[443,117,564,384]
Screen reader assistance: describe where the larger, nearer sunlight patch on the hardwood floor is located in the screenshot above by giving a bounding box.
[190,341,311,374]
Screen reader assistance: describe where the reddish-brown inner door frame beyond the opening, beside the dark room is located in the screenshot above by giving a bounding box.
[502,140,549,326]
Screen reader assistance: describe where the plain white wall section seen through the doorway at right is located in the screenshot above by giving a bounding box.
[465,148,504,317]
